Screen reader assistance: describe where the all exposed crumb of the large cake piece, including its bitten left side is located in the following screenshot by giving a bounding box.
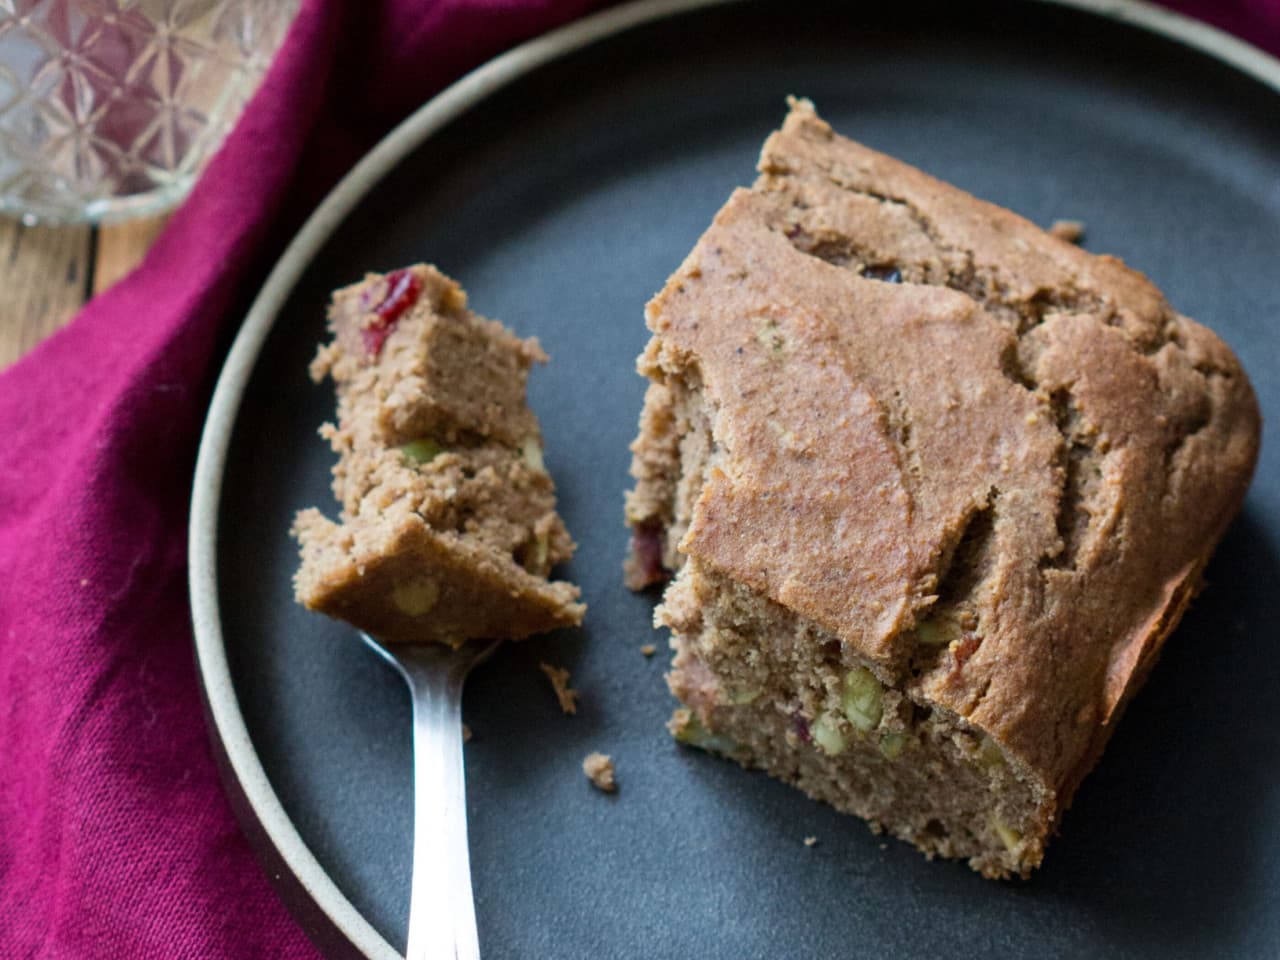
[627,376,1052,877]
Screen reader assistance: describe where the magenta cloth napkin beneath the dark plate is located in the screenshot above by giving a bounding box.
[0,0,1280,960]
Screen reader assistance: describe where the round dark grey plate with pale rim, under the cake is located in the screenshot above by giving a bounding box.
[192,0,1280,960]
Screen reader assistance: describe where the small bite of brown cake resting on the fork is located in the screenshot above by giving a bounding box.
[293,265,585,644]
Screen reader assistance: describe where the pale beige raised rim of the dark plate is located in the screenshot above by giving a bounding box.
[188,0,1280,960]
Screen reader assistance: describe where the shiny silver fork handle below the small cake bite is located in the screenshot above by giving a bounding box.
[361,634,500,960]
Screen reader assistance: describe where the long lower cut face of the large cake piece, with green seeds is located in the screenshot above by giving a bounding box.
[659,561,1044,877]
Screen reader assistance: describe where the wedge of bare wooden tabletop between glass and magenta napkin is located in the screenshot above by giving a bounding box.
[0,215,168,370]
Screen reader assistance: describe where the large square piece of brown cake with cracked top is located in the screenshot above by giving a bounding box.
[627,101,1260,877]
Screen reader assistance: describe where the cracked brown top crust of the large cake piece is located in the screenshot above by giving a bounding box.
[628,101,1260,870]
